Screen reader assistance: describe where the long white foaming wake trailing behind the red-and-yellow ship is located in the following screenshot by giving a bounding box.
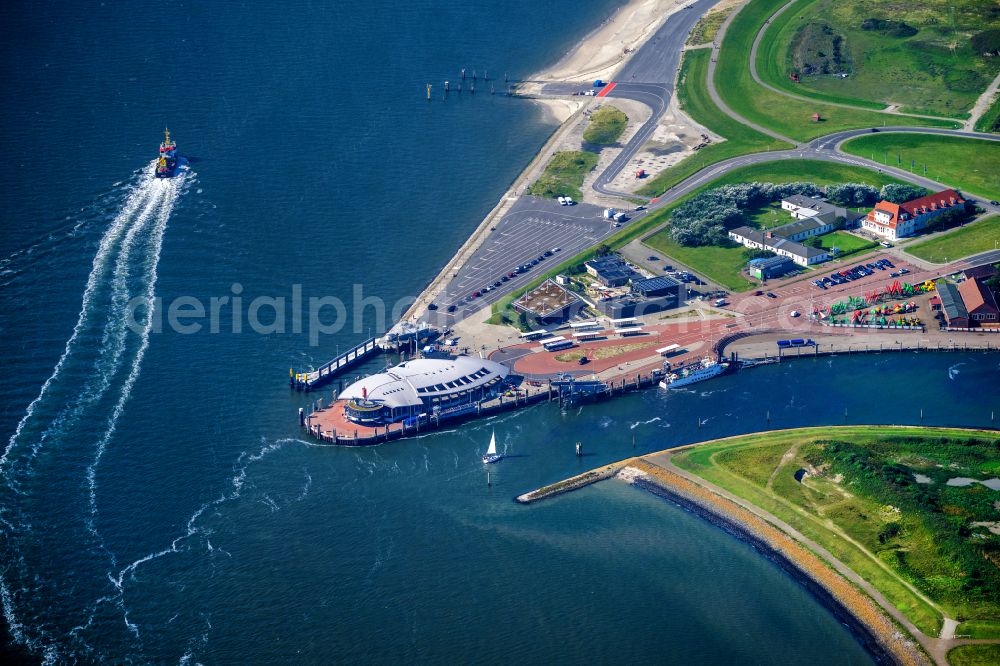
[0,165,192,662]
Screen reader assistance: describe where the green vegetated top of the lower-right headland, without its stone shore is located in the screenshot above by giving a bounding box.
[673,426,1000,637]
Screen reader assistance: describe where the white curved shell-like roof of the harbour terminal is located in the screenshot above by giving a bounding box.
[338,356,510,407]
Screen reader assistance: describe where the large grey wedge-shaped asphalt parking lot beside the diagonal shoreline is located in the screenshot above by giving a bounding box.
[424,196,640,326]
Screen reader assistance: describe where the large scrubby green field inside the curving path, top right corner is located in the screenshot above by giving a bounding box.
[757,0,1000,117]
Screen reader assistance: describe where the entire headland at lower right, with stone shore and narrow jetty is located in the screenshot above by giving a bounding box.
[521,426,1000,664]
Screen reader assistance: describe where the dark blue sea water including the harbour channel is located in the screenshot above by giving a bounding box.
[0,0,1000,664]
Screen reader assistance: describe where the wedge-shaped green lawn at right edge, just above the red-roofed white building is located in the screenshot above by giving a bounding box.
[843,132,1000,199]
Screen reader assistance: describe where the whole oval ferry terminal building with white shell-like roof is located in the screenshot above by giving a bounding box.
[338,356,510,425]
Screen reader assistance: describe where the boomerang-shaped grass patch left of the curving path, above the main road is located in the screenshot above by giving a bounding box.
[638,48,791,196]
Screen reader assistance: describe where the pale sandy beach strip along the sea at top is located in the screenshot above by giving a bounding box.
[530,0,686,81]
